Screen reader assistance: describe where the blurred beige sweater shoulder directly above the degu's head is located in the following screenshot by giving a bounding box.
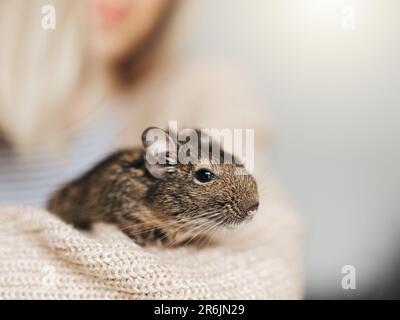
[120,59,272,149]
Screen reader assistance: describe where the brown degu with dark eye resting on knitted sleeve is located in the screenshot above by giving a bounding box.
[48,127,259,247]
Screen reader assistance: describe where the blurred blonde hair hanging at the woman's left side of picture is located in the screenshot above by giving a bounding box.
[0,0,102,150]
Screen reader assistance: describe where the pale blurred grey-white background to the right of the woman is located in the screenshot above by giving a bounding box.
[177,0,400,298]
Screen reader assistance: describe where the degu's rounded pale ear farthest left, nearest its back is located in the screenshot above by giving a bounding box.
[142,127,177,179]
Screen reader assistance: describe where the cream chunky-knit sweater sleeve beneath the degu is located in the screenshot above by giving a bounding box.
[0,184,302,299]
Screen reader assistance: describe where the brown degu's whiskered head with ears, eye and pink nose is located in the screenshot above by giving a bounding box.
[142,127,259,227]
